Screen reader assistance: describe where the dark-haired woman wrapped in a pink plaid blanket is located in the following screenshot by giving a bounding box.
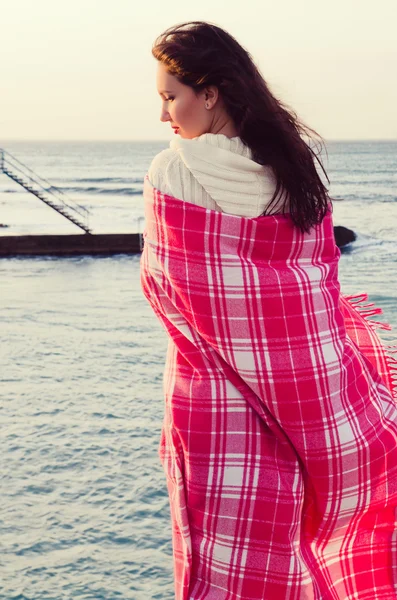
[141,22,397,600]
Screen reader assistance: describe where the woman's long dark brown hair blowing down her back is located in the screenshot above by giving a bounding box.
[152,21,331,231]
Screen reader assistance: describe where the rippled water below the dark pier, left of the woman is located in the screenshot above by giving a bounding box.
[0,257,174,600]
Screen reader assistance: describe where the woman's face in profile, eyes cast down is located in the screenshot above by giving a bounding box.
[157,62,211,139]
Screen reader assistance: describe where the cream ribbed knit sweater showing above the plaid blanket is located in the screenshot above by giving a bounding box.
[148,133,284,217]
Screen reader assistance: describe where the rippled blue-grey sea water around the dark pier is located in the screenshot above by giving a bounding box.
[0,142,397,600]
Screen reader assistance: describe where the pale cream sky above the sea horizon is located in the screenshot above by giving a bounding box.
[0,0,397,141]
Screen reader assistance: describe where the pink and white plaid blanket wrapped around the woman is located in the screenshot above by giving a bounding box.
[141,178,397,600]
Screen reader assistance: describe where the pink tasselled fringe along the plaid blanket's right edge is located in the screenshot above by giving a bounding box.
[344,292,397,400]
